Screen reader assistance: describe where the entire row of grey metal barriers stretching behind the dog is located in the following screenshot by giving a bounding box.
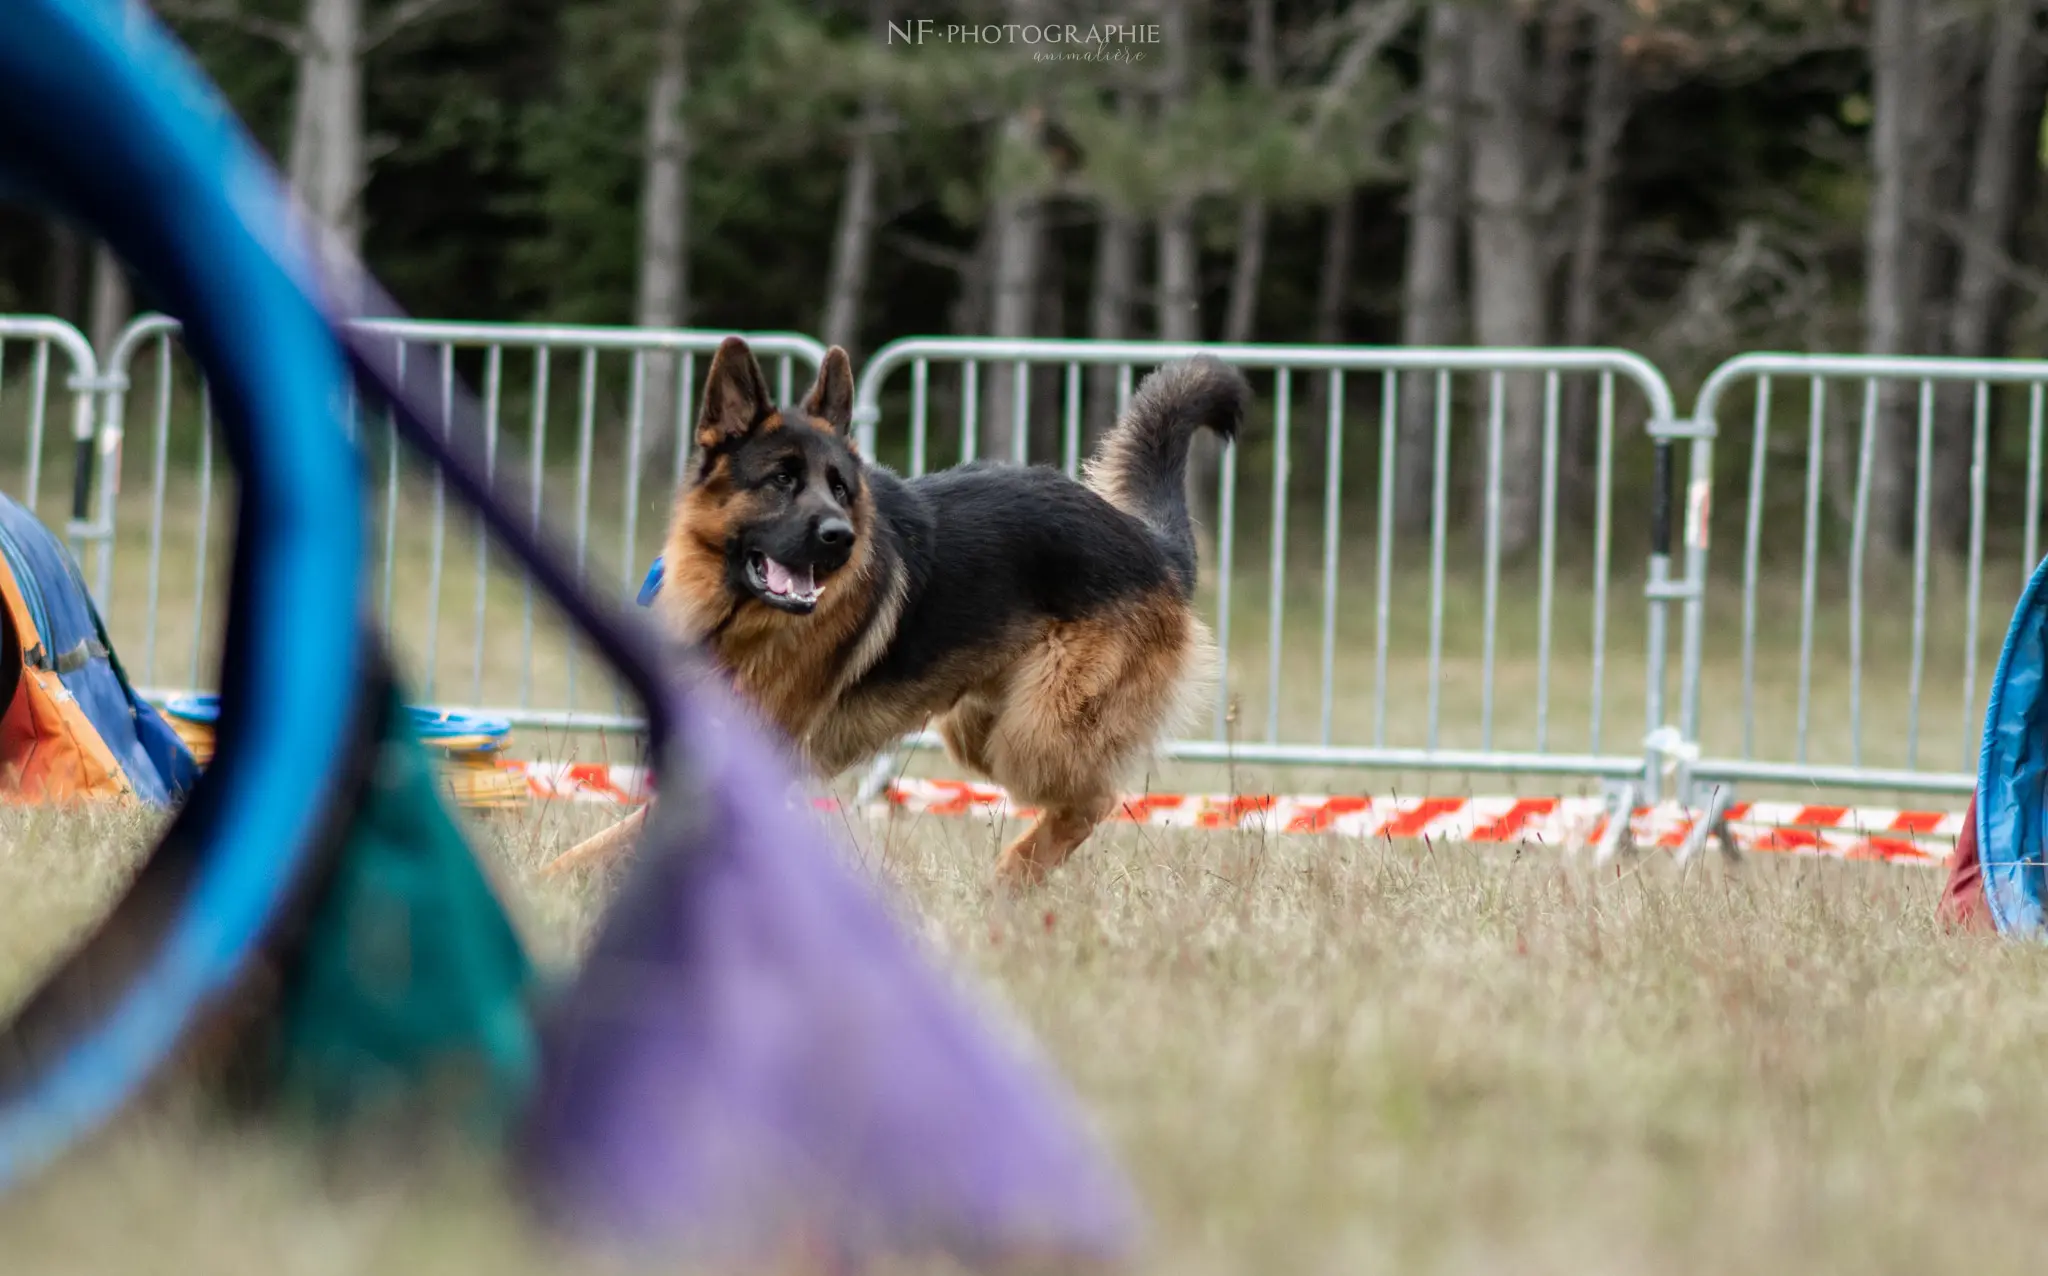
[0,315,2048,830]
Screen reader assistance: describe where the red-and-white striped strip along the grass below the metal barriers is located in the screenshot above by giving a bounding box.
[502,762,1964,864]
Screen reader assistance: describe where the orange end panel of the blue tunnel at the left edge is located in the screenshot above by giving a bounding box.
[0,569,133,805]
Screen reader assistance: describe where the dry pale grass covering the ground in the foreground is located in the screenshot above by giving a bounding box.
[0,807,2048,1276]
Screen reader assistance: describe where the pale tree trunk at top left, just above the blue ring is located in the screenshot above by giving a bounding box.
[289,0,365,254]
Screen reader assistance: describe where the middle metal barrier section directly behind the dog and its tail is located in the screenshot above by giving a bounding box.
[854,338,1683,819]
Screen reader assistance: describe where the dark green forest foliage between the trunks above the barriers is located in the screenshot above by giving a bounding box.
[12,0,2048,380]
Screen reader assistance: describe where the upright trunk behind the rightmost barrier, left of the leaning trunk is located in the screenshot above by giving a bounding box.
[1864,0,1927,551]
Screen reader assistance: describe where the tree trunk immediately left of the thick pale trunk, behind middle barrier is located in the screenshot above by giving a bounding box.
[1395,0,1470,528]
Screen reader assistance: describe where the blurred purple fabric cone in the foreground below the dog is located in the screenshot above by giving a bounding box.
[526,690,1135,1262]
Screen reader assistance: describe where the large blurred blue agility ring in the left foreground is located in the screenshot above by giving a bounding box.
[0,0,371,1190]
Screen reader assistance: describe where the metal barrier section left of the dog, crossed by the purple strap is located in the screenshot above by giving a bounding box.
[98,315,823,729]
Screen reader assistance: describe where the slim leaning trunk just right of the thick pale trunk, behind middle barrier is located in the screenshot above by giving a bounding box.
[1559,8,1628,520]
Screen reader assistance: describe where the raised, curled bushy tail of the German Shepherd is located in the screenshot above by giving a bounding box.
[1085,354,1251,594]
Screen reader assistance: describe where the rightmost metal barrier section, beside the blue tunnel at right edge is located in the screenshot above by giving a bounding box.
[1677,354,2048,807]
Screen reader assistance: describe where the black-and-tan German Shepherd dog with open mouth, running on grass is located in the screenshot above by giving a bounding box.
[549,338,1251,885]
